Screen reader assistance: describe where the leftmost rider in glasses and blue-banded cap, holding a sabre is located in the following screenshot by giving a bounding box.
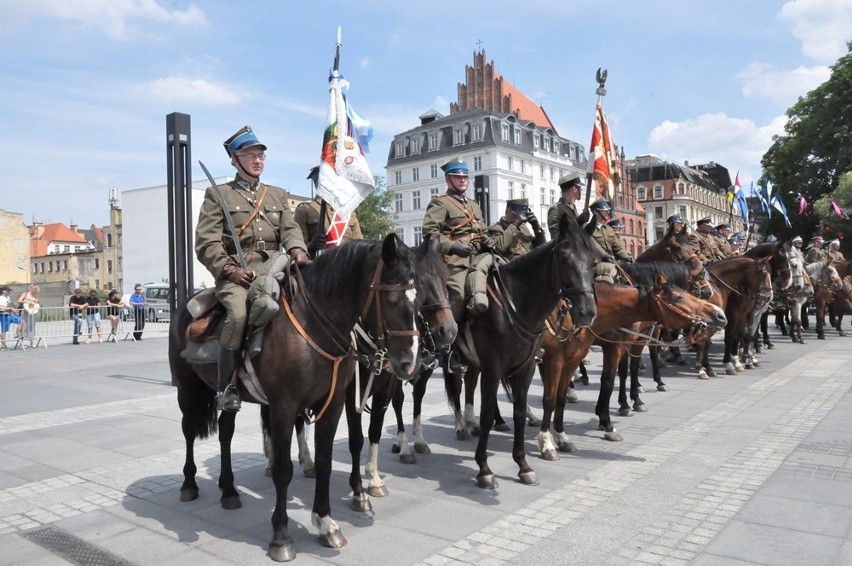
[195,126,311,411]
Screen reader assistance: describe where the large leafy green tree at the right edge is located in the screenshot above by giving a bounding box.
[761,42,852,241]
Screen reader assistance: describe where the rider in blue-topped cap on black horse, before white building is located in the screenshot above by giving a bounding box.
[423,159,494,373]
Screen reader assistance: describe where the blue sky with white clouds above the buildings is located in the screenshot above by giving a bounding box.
[0,0,852,227]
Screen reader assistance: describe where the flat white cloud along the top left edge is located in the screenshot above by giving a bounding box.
[4,0,207,40]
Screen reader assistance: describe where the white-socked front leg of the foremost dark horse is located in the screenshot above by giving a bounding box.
[310,402,351,548]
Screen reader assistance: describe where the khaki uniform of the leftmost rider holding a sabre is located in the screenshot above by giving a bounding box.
[195,178,307,350]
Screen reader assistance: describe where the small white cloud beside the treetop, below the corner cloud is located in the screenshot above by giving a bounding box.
[737,63,831,108]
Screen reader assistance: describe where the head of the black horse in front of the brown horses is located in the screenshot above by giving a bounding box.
[553,216,597,329]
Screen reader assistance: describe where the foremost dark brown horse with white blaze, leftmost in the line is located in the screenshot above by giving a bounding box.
[169,234,420,561]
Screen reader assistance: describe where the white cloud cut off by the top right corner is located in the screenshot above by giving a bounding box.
[778,0,852,63]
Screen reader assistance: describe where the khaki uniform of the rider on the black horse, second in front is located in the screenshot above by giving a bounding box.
[423,192,487,321]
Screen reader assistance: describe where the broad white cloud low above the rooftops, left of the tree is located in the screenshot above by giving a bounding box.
[648,112,787,179]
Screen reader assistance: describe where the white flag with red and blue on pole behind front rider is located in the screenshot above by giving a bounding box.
[317,38,376,248]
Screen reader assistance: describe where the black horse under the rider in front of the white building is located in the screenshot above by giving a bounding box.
[444,218,596,489]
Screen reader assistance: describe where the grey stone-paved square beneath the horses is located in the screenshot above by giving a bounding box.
[0,328,852,566]
